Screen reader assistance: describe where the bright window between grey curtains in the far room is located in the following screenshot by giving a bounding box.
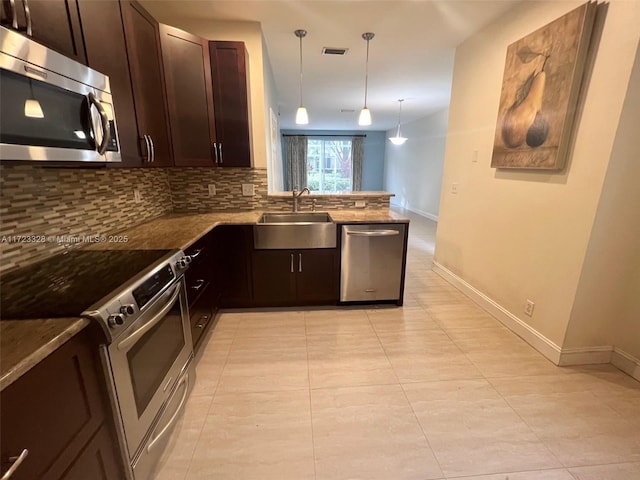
[307,137,353,193]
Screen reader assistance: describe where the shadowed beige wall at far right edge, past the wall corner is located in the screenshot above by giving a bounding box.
[565,40,640,358]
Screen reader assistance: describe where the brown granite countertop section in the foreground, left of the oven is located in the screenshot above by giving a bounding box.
[0,317,89,390]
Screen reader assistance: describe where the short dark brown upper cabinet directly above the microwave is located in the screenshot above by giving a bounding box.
[0,0,87,64]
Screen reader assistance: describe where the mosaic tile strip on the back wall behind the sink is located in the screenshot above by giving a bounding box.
[169,167,389,213]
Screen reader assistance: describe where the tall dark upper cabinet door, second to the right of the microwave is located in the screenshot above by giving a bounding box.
[120,0,173,167]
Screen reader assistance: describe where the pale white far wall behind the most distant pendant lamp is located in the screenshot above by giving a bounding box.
[384,110,449,220]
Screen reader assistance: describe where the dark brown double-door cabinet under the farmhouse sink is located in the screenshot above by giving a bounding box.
[252,249,338,307]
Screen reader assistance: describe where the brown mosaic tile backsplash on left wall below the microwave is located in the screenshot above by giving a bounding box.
[0,164,172,272]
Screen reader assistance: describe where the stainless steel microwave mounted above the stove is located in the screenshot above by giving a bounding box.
[0,27,121,163]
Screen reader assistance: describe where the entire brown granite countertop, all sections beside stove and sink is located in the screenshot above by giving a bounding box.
[0,209,409,390]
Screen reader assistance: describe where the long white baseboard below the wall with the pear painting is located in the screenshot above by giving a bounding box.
[433,261,562,365]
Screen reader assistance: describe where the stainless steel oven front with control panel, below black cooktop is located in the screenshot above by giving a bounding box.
[85,252,195,480]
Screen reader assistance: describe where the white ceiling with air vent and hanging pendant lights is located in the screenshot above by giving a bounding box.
[143,0,521,130]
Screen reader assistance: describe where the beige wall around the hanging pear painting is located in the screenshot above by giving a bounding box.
[435,0,640,346]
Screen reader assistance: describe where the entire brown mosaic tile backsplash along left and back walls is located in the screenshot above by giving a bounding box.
[0,164,389,272]
